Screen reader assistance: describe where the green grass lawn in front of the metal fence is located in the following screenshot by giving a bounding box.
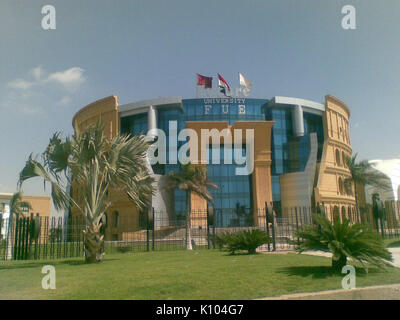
[0,250,400,299]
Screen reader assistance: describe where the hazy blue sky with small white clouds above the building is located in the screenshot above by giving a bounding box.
[0,0,400,201]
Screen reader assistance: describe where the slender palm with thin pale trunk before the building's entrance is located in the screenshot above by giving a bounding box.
[164,163,218,250]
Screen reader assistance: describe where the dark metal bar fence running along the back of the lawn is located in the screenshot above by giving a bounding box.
[0,202,400,260]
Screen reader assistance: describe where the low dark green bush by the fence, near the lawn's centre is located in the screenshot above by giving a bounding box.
[216,230,271,254]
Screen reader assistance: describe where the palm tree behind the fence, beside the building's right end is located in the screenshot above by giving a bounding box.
[344,154,390,208]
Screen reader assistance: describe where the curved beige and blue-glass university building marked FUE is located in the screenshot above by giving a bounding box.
[73,95,355,238]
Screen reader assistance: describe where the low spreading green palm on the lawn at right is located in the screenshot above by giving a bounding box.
[294,215,392,272]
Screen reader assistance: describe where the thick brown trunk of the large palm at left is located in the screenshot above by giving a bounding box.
[83,223,104,263]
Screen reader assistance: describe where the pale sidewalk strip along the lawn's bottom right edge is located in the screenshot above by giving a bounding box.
[258,284,400,300]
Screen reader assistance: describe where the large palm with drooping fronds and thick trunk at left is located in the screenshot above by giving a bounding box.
[19,122,153,263]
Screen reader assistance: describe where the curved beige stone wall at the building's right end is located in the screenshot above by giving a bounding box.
[315,95,355,220]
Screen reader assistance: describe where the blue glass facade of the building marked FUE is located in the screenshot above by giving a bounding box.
[121,98,323,226]
